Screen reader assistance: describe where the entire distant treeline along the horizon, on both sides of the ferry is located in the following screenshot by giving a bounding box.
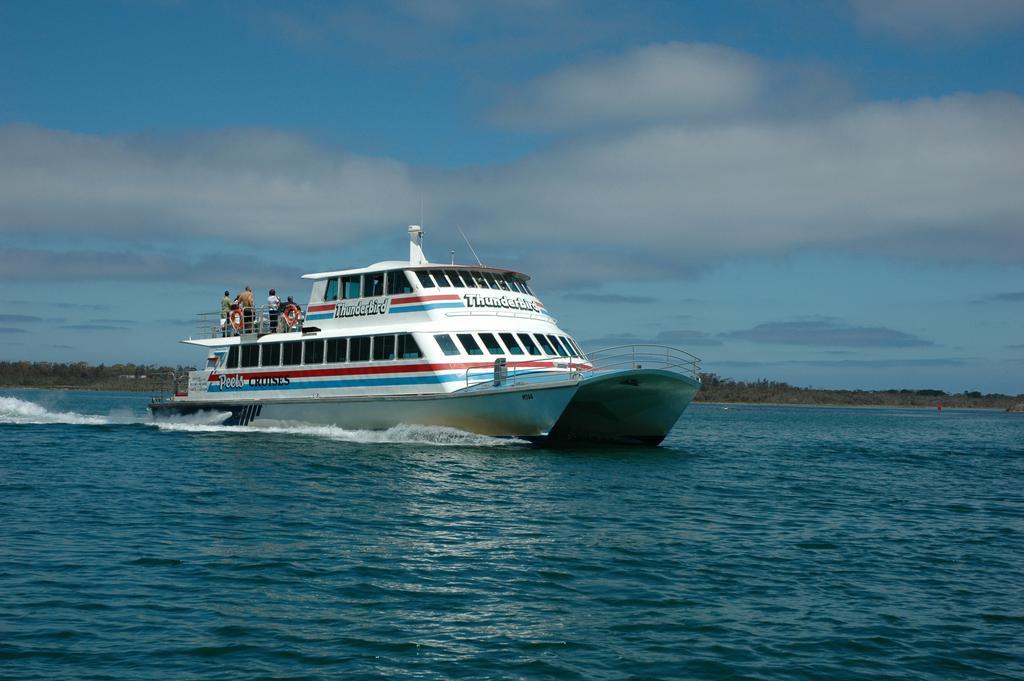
[0,361,1024,410]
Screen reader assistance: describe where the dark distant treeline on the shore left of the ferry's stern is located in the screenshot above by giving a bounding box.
[0,361,190,392]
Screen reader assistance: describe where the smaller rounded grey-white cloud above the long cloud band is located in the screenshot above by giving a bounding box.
[492,43,767,130]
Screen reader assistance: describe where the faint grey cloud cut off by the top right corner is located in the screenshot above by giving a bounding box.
[852,0,1024,38]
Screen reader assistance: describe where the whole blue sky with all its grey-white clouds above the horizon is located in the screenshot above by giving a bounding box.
[0,0,1024,394]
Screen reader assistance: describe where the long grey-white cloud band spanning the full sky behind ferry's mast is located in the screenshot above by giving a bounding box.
[0,89,1024,284]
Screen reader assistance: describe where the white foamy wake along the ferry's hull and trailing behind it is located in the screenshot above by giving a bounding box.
[0,396,520,446]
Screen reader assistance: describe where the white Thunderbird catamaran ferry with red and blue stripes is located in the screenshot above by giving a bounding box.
[150,225,700,445]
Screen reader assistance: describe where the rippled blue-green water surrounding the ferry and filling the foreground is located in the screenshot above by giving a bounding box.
[0,390,1024,680]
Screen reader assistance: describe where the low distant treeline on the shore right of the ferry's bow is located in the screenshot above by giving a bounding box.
[693,374,1024,410]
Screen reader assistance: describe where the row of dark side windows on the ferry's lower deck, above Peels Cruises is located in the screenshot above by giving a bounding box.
[227,334,423,369]
